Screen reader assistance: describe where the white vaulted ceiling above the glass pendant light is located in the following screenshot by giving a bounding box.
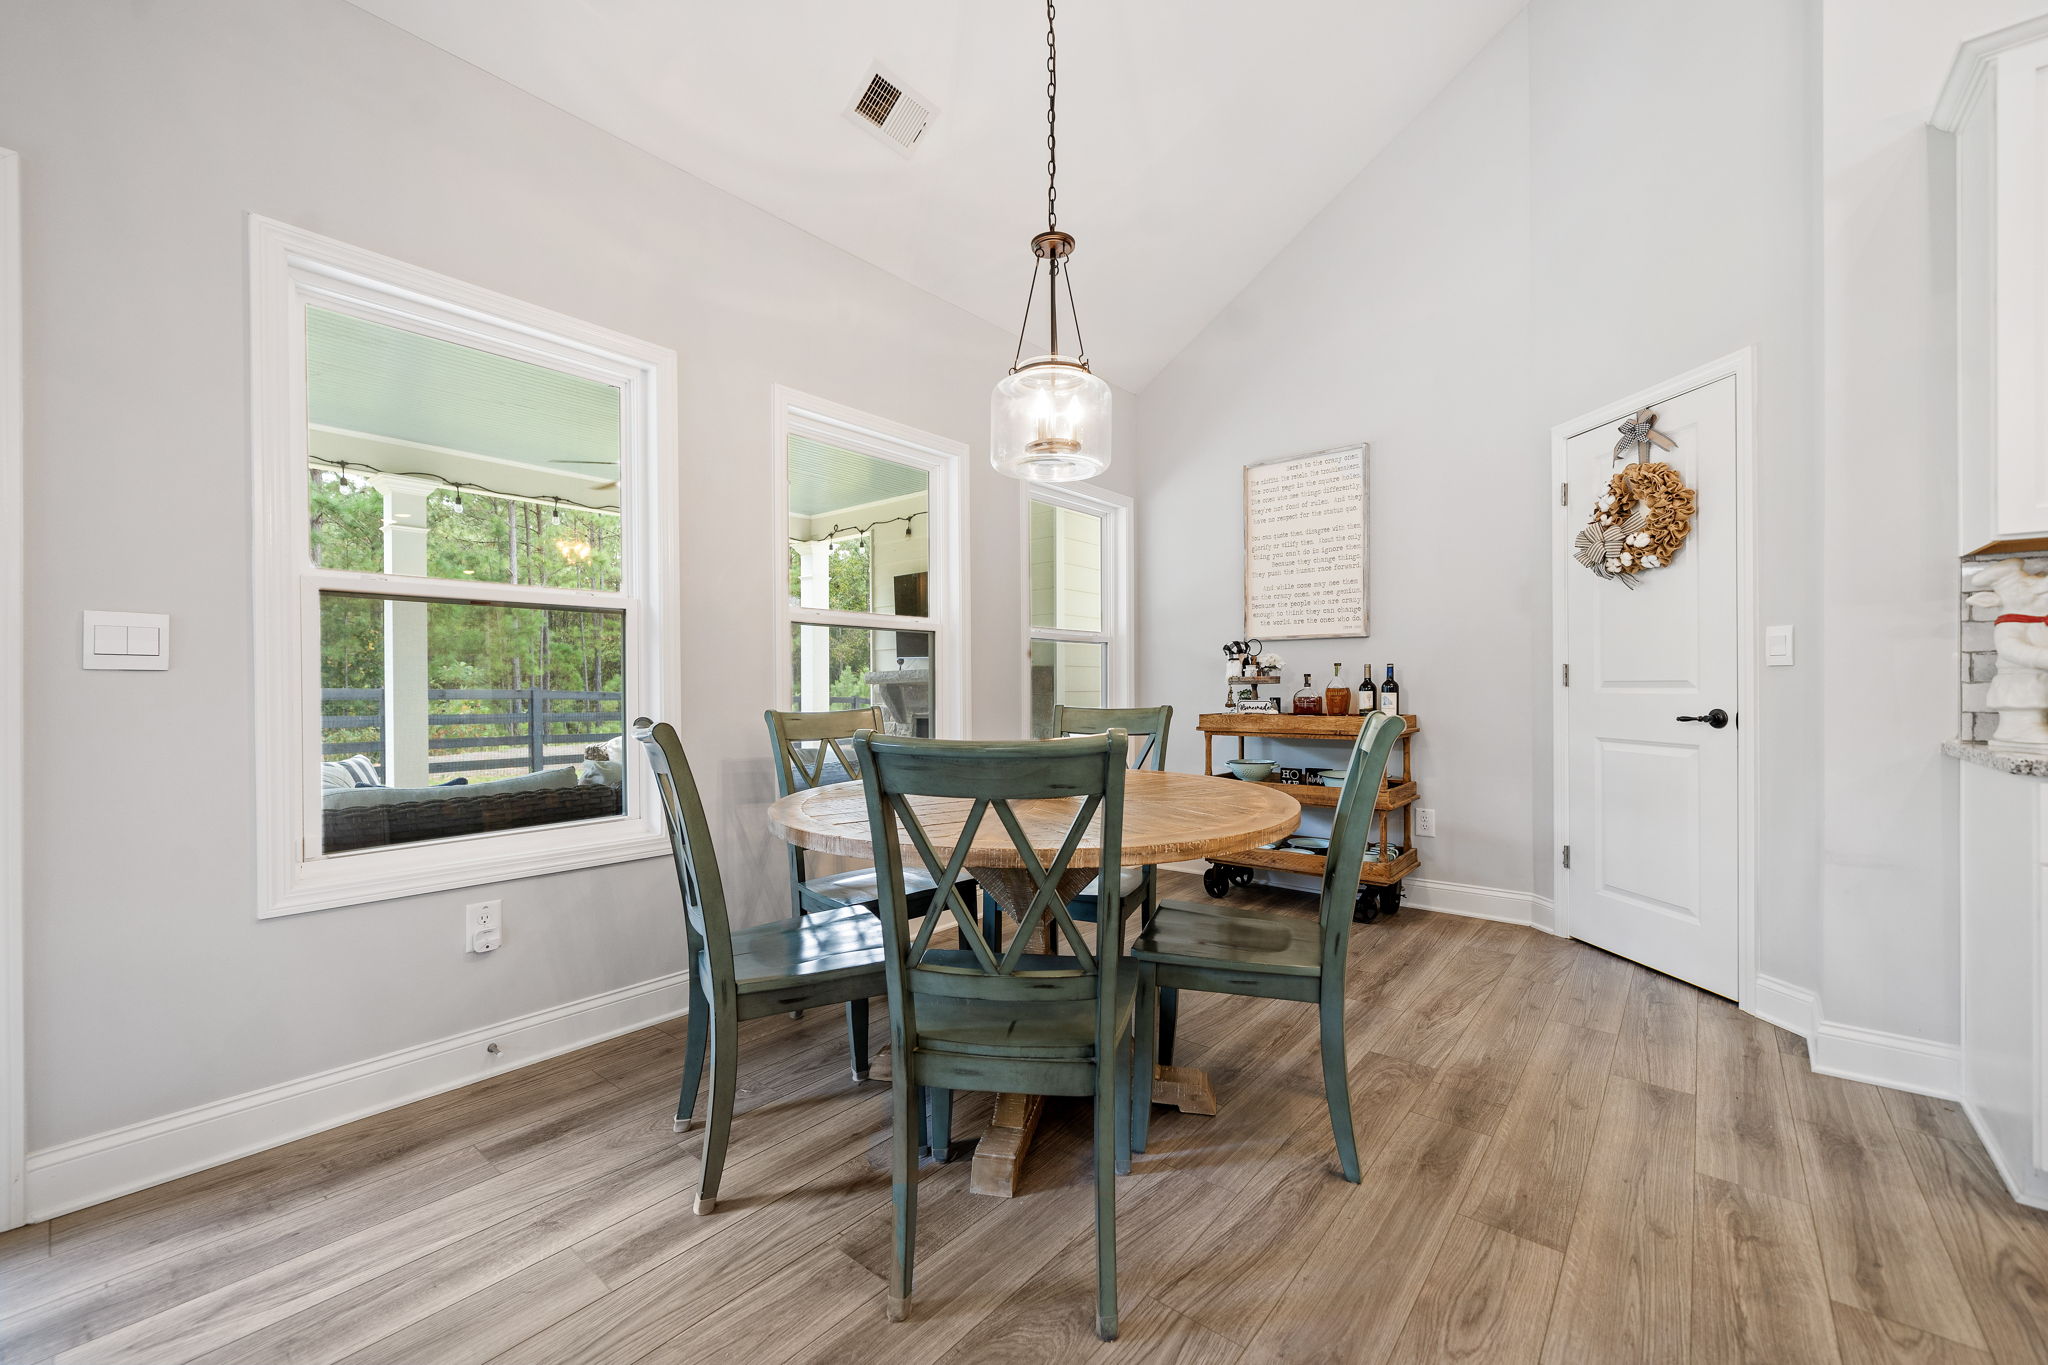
[354,0,1522,389]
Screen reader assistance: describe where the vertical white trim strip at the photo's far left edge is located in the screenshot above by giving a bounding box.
[0,147,29,1230]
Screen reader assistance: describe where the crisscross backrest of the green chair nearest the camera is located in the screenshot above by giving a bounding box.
[854,731,1128,1031]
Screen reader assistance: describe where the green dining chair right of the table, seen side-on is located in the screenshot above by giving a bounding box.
[1130,712,1405,1185]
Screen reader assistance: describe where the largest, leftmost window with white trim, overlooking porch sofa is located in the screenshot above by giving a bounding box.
[252,219,674,913]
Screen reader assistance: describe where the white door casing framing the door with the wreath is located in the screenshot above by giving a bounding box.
[1548,346,1765,1007]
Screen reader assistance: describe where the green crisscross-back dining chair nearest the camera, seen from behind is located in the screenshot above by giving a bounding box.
[854,731,1137,1340]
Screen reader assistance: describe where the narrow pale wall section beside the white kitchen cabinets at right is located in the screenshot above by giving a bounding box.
[1821,0,2044,1044]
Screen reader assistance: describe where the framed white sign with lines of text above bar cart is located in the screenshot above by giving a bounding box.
[1245,442,1370,641]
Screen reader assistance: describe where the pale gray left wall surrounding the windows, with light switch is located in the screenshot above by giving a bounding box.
[0,0,1137,1150]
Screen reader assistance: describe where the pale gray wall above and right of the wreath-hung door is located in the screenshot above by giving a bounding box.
[1528,0,1823,1002]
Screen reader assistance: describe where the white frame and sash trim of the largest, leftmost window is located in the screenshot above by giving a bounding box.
[250,215,682,919]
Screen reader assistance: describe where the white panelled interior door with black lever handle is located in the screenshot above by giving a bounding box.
[1561,377,1739,997]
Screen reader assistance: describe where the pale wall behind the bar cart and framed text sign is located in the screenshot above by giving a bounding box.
[1137,18,1550,892]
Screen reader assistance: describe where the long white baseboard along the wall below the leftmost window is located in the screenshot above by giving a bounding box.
[27,972,688,1222]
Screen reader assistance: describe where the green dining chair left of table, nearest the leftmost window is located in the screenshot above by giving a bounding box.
[633,716,887,1214]
